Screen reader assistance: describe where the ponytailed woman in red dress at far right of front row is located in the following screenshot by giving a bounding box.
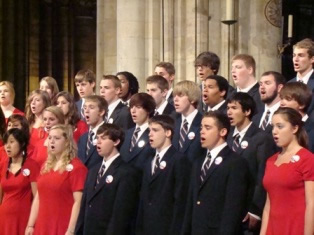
[261,108,314,235]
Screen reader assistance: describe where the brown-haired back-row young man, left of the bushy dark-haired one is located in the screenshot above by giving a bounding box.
[155,62,176,105]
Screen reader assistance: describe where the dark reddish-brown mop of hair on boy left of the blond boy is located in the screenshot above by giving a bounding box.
[130,92,156,117]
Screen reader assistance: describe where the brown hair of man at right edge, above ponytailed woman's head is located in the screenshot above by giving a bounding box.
[279,82,312,112]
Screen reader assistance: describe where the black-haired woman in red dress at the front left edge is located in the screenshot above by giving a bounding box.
[0,128,39,235]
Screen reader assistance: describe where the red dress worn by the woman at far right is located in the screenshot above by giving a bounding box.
[263,148,314,235]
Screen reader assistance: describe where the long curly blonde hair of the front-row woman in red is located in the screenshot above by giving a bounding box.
[41,124,77,174]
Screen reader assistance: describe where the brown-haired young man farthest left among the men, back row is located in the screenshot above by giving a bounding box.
[74,69,96,121]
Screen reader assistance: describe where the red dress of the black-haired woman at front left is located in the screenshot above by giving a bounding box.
[0,158,39,235]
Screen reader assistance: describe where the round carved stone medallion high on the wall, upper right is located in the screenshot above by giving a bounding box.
[265,0,282,28]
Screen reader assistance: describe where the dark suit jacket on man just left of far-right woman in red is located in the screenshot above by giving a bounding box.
[227,123,277,217]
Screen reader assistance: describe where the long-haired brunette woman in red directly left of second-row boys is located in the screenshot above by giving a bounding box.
[55,91,88,143]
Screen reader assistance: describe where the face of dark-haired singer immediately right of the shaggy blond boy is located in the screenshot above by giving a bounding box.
[203,79,226,108]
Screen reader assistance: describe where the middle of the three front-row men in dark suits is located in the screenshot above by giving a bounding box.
[136,115,190,235]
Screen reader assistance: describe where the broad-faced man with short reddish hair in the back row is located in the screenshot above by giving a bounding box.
[231,54,263,115]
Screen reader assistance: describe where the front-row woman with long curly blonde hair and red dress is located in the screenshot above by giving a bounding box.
[25,125,87,235]
